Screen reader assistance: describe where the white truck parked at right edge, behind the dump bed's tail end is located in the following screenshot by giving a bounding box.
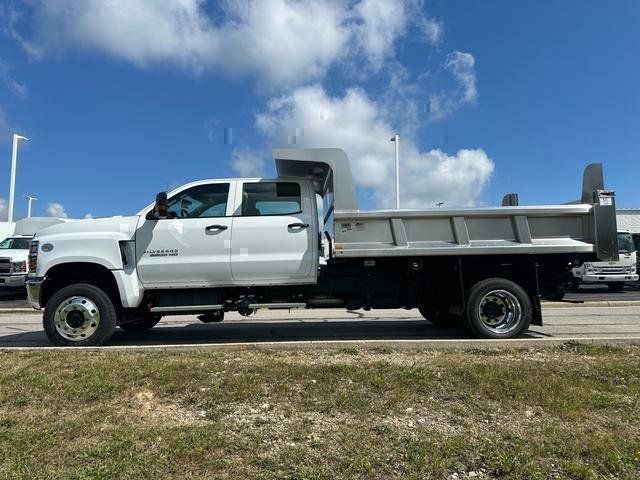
[572,232,638,292]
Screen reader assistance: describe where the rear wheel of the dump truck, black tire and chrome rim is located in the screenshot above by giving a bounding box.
[465,278,533,338]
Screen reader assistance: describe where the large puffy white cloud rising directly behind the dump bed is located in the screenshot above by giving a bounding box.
[256,85,494,207]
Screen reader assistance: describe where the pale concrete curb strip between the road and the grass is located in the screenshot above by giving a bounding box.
[0,337,640,353]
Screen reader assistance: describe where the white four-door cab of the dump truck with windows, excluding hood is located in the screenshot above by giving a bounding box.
[135,178,318,289]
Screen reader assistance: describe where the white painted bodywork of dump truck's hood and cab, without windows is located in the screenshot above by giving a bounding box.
[32,179,318,308]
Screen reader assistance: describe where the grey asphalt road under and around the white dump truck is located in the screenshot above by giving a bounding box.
[0,287,640,348]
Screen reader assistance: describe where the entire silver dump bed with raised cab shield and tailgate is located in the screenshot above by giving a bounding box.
[273,148,618,261]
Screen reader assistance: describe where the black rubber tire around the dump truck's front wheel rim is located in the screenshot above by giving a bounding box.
[42,283,117,347]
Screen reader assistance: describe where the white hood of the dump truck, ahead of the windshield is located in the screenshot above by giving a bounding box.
[34,215,140,242]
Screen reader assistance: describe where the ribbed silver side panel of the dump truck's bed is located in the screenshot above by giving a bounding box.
[334,205,596,257]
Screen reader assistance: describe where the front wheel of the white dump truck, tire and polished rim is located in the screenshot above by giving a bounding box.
[42,283,117,347]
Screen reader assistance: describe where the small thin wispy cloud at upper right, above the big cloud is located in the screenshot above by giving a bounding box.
[429,51,478,120]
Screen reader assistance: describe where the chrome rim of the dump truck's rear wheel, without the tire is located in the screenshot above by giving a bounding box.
[478,290,522,334]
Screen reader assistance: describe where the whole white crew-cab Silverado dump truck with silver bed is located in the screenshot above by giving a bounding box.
[27,149,618,345]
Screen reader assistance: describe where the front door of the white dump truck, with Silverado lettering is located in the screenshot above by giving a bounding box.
[136,181,235,288]
